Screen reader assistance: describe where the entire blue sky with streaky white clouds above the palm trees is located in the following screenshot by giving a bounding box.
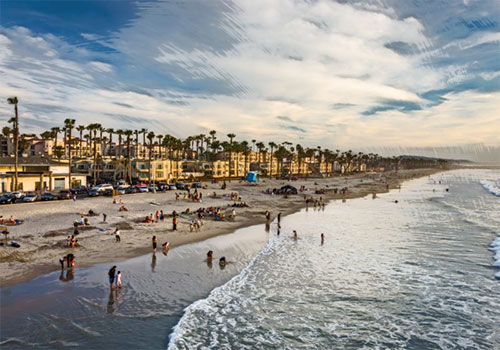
[0,0,500,163]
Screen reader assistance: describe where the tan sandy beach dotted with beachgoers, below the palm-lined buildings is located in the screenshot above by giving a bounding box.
[0,169,439,286]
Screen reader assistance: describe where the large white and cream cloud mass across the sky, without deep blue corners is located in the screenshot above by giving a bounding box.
[0,0,500,160]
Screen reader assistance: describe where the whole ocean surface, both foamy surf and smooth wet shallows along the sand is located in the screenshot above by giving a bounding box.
[0,170,500,350]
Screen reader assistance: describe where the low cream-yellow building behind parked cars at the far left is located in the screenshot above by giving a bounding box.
[0,157,87,192]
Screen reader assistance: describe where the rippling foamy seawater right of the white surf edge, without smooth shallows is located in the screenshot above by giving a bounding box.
[168,170,500,350]
